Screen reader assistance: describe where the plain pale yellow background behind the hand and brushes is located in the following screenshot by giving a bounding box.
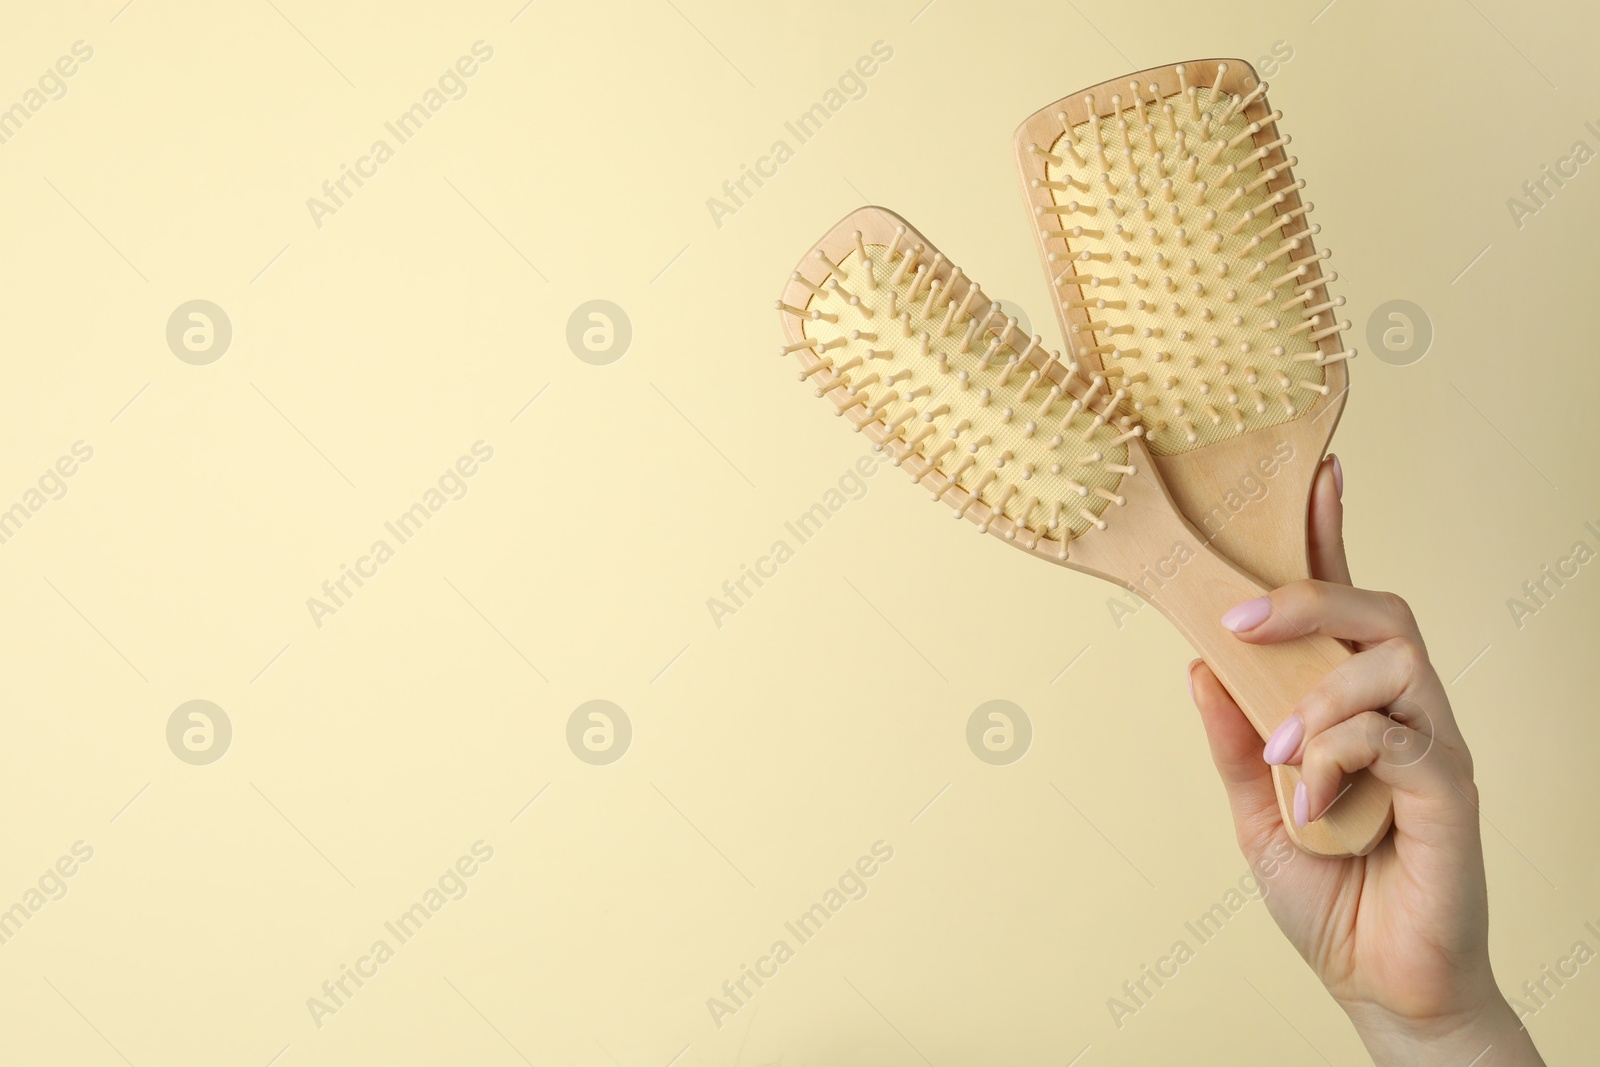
[0,0,1600,1067]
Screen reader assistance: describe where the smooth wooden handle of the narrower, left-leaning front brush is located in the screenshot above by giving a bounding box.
[1136,537,1394,856]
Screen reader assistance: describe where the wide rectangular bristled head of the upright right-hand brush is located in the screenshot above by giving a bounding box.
[1018,61,1355,456]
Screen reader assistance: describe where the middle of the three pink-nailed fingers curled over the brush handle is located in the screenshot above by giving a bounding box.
[1262,637,1459,765]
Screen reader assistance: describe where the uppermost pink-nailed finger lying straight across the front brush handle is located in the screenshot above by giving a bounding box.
[1222,579,1422,648]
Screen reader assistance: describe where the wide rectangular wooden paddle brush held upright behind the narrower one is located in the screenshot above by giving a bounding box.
[1014,59,1389,856]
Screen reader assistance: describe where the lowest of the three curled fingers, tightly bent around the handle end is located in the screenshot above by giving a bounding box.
[1294,712,1478,838]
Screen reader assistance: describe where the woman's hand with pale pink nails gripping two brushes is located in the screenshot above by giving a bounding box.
[1189,458,1544,1067]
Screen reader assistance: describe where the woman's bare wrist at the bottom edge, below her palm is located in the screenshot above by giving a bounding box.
[1344,992,1544,1067]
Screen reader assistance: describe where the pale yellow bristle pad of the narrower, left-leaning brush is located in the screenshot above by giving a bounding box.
[797,245,1131,547]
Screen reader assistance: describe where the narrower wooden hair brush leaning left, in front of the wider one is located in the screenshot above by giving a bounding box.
[778,208,1389,853]
